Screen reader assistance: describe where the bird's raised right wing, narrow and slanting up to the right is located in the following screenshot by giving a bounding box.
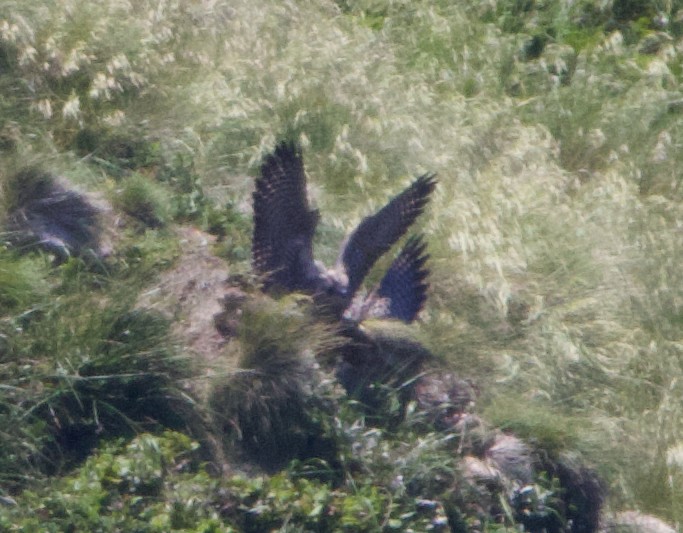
[337,173,436,295]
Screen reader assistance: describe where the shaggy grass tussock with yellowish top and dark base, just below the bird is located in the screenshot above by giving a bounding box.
[209,297,339,469]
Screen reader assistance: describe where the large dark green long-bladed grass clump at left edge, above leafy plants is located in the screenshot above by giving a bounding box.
[0,284,199,484]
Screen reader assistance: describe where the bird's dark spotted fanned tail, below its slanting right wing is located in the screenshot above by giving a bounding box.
[375,236,429,323]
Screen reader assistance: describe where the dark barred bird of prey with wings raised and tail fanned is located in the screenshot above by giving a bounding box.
[252,142,436,322]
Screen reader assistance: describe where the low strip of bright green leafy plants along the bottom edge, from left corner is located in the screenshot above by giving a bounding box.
[0,432,456,533]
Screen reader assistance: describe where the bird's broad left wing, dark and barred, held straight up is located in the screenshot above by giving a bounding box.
[252,142,319,290]
